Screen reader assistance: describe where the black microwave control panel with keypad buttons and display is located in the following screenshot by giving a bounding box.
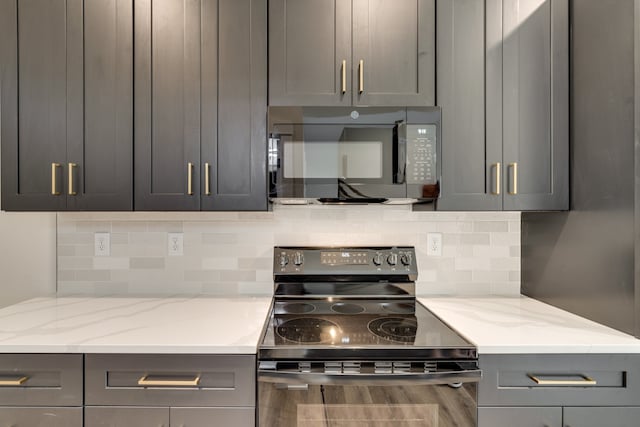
[406,124,438,184]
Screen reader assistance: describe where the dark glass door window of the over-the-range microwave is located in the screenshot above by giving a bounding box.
[281,125,394,179]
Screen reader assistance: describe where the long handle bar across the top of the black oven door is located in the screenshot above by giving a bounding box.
[258,369,482,386]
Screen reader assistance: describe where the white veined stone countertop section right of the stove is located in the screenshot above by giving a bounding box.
[419,296,640,355]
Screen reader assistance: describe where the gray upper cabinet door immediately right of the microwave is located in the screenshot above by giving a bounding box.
[437,0,502,210]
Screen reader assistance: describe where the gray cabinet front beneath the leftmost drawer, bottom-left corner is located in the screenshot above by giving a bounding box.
[0,406,82,427]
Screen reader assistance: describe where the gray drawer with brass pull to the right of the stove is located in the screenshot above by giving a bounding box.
[478,354,640,406]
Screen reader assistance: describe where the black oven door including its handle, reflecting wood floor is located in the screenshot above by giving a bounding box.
[258,370,480,427]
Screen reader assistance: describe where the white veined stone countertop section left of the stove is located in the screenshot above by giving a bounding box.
[0,296,271,354]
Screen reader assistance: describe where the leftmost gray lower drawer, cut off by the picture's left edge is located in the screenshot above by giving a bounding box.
[0,354,82,408]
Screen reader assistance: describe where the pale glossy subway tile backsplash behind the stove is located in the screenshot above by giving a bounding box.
[57,205,520,295]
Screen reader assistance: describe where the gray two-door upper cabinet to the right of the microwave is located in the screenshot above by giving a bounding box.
[437,0,569,210]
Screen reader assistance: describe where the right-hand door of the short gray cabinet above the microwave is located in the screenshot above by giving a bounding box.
[351,0,435,106]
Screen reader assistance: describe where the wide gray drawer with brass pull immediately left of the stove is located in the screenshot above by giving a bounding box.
[85,354,256,407]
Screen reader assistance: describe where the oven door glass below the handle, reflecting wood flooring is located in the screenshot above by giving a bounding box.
[258,382,477,427]
